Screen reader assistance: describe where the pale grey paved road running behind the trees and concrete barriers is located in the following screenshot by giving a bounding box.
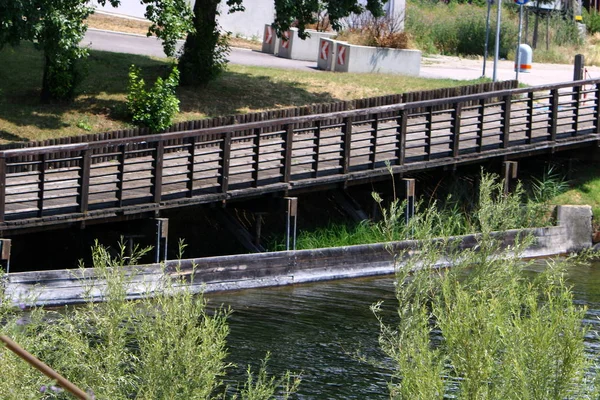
[82,29,600,86]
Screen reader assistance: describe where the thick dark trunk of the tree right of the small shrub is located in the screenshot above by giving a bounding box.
[179,0,228,86]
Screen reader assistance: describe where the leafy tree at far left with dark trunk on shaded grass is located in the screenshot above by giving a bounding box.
[0,0,192,102]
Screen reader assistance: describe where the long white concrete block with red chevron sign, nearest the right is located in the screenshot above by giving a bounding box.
[334,42,421,76]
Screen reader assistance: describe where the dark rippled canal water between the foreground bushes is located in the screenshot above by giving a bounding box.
[207,263,600,399]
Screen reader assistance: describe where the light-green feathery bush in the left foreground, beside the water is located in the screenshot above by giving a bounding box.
[0,241,299,400]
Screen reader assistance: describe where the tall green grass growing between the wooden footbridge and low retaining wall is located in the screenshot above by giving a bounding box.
[269,170,567,249]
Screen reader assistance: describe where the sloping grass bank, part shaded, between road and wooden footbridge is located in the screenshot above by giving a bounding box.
[0,43,480,143]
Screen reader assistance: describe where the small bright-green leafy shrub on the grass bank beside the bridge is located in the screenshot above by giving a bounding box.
[127,65,179,133]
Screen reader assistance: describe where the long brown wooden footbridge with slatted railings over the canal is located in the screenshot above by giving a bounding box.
[0,80,600,234]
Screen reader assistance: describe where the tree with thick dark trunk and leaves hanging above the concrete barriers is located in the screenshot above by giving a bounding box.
[179,0,387,85]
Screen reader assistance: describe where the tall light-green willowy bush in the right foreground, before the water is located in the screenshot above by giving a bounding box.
[372,177,598,400]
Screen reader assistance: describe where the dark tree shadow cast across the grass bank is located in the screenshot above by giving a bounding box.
[0,43,335,140]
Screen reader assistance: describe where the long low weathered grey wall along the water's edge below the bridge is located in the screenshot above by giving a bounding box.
[4,206,592,305]
